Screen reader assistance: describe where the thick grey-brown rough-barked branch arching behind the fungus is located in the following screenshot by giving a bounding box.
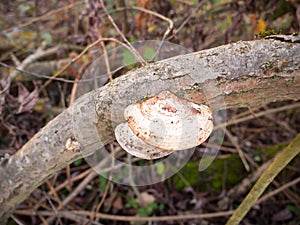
[0,36,300,224]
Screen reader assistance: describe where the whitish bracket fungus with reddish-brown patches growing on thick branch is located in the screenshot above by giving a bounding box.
[115,91,213,159]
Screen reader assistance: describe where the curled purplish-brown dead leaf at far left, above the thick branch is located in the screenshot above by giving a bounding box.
[16,83,39,114]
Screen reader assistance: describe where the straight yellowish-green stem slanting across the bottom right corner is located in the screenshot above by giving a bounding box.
[226,134,300,225]
